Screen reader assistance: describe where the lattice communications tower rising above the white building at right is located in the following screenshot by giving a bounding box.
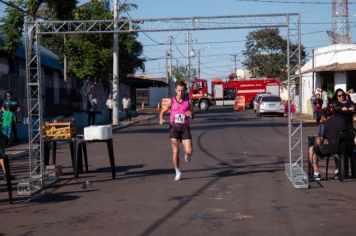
[329,0,351,44]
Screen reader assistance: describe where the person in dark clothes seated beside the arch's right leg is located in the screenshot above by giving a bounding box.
[309,108,346,181]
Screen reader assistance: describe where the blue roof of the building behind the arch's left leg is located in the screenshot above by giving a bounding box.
[0,35,63,71]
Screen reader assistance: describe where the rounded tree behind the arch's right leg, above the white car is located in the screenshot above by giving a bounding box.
[243,28,305,80]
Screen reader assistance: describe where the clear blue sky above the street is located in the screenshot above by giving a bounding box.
[0,0,356,79]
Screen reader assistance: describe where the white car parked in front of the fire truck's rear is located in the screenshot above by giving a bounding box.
[256,95,284,117]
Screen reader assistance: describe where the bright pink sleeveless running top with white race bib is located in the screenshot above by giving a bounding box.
[169,97,190,126]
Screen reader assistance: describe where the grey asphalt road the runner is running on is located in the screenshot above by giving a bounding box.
[0,108,356,236]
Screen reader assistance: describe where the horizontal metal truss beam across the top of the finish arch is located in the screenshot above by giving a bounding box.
[29,13,299,35]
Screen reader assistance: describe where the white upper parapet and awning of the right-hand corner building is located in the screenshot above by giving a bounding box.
[301,44,356,74]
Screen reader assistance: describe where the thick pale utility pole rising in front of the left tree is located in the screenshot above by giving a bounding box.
[112,0,119,125]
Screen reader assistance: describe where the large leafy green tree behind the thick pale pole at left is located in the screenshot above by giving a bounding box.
[60,0,144,83]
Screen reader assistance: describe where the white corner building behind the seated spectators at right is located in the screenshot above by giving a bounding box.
[301,44,356,114]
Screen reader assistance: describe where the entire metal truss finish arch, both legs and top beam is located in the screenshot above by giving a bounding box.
[18,13,308,195]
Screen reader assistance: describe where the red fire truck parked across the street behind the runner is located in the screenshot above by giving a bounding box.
[189,78,279,110]
